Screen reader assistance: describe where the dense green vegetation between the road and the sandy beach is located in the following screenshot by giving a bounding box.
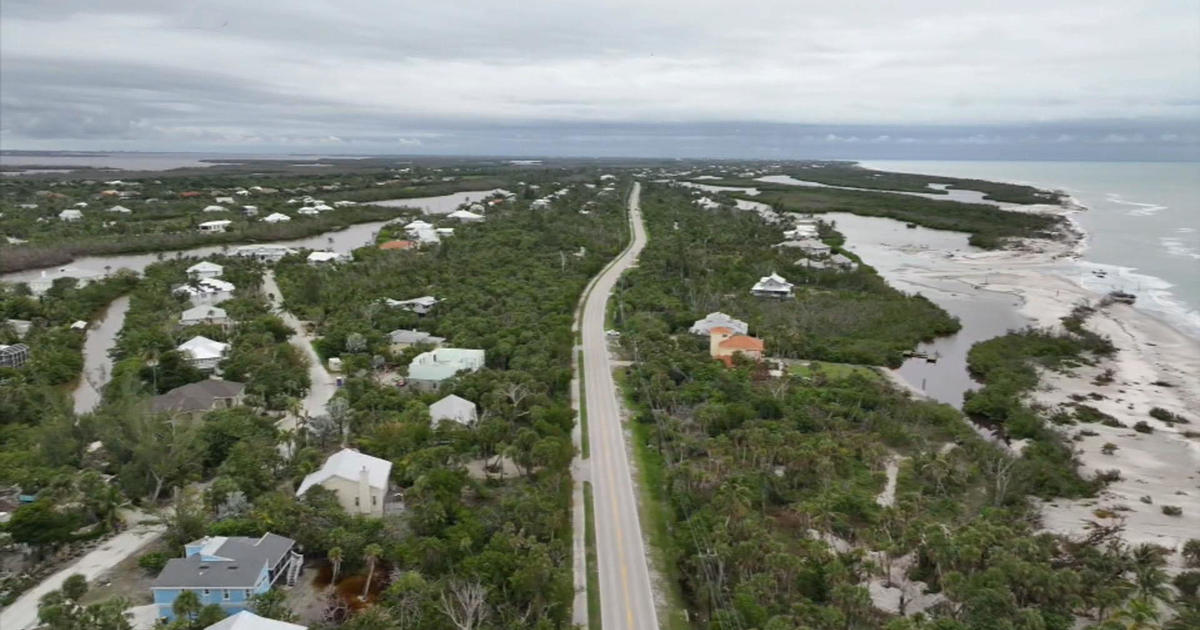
[617,188,1196,630]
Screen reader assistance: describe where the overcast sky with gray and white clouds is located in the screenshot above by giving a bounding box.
[0,0,1200,160]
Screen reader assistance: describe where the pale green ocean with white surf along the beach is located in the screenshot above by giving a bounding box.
[862,160,1200,338]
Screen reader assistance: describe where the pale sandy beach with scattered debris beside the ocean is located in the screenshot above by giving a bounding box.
[847,198,1200,562]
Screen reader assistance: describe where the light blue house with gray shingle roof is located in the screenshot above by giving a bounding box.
[150,533,304,619]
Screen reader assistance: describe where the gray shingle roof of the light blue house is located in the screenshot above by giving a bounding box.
[150,534,295,588]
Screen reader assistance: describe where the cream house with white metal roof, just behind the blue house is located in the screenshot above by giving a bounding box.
[296,449,391,516]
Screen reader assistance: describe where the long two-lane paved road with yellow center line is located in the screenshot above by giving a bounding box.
[582,178,659,630]
